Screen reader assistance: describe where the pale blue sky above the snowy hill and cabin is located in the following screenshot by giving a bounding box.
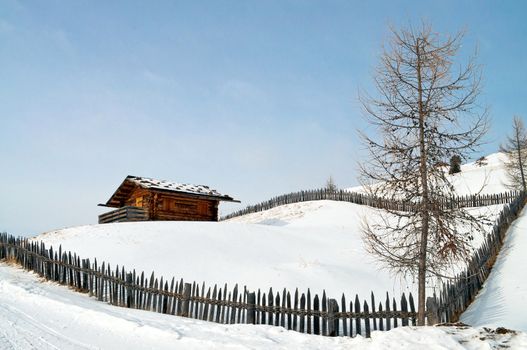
[0,0,527,235]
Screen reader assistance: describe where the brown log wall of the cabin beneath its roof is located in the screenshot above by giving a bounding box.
[125,188,219,221]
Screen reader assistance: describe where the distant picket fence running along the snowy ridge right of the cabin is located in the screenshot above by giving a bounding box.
[221,188,519,220]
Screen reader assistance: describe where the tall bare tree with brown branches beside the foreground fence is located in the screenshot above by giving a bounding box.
[360,24,487,325]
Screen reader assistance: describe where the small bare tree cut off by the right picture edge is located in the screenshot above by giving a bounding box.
[500,116,527,191]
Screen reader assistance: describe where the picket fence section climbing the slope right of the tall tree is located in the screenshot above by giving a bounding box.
[427,192,526,322]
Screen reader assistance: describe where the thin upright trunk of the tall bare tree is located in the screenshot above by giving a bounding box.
[416,39,430,326]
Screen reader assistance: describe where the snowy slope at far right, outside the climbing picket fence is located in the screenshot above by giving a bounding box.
[461,205,527,331]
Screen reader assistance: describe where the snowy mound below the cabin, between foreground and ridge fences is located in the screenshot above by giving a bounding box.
[37,201,502,299]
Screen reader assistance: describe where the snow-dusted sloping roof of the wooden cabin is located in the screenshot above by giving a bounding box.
[100,175,238,207]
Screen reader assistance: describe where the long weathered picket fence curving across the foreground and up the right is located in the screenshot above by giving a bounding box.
[0,193,525,337]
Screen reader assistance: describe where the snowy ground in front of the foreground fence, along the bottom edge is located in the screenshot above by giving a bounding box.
[0,263,527,350]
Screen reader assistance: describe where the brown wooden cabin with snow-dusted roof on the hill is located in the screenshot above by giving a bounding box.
[99,175,240,224]
